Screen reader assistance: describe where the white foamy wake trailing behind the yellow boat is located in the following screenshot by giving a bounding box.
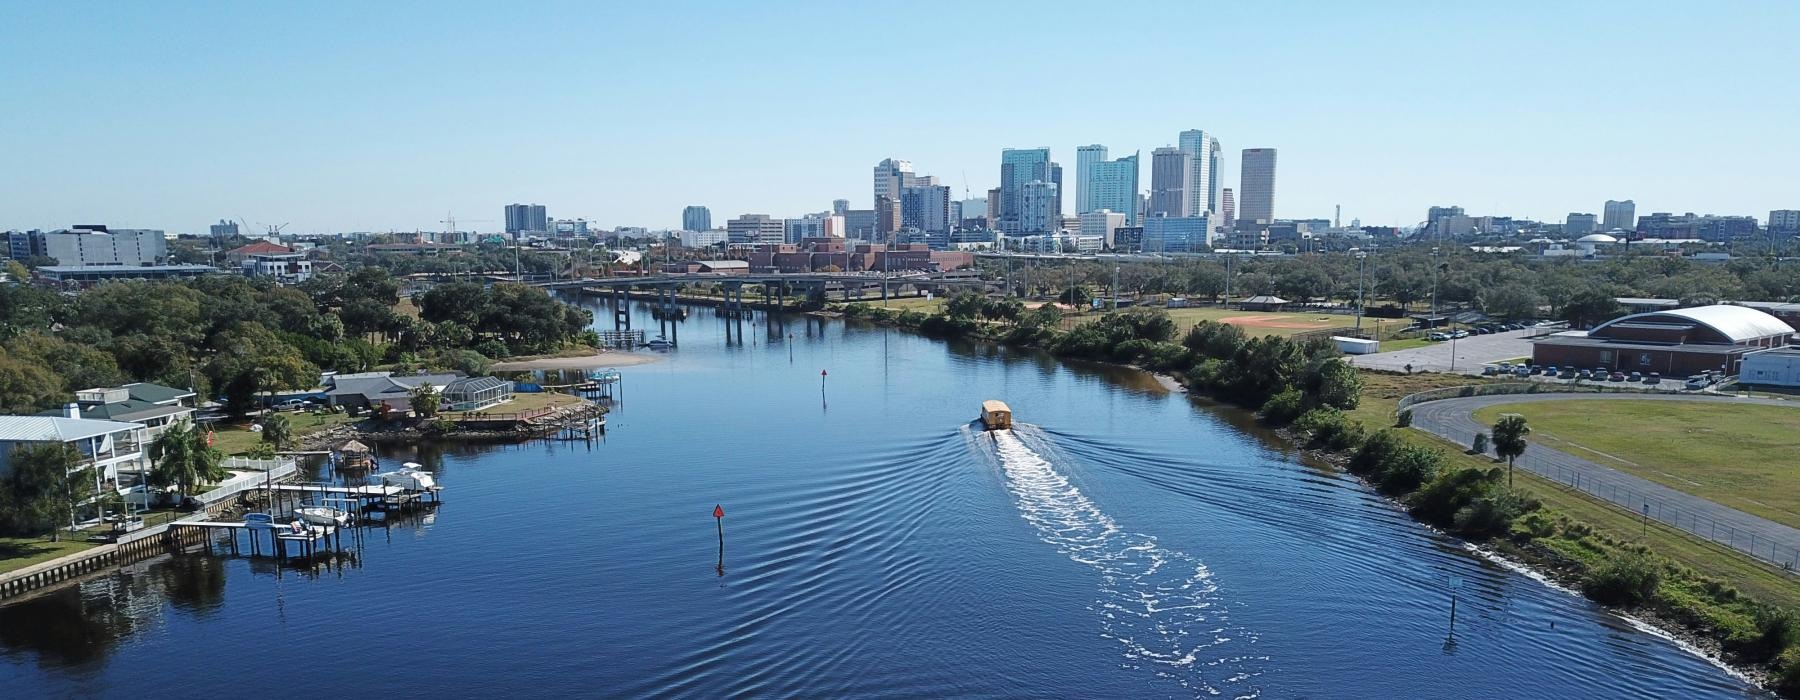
[972,426,1267,698]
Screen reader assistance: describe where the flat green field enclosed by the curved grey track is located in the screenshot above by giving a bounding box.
[1476,401,1800,527]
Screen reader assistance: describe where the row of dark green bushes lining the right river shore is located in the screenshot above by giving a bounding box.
[842,293,1800,698]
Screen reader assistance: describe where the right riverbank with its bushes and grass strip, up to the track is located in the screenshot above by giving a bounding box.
[846,298,1800,696]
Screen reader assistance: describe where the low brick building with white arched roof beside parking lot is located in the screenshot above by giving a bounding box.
[1532,304,1795,376]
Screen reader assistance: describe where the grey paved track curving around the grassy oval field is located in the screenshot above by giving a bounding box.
[1413,394,1800,569]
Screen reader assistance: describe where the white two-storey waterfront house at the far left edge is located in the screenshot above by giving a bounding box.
[0,403,149,522]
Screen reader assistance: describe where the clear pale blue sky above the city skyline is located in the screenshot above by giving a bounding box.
[0,0,1800,234]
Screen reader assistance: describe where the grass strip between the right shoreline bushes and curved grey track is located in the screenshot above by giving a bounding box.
[1352,372,1800,606]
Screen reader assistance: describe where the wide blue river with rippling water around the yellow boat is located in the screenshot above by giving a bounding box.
[0,298,1757,698]
